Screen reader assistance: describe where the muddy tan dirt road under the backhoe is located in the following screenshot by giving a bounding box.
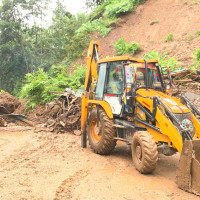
[0,128,199,200]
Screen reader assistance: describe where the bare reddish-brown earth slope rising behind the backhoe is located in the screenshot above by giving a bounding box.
[88,0,200,67]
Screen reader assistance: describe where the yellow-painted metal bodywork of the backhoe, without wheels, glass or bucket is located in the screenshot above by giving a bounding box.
[81,42,200,153]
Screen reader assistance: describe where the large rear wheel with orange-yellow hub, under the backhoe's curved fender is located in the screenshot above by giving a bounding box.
[88,108,116,155]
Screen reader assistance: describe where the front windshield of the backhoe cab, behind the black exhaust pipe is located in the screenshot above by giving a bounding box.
[125,63,161,88]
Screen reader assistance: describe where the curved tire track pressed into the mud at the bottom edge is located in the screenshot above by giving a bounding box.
[54,170,89,200]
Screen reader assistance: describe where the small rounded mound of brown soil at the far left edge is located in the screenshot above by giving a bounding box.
[0,92,20,113]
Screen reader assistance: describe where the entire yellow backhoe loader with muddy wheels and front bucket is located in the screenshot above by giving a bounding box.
[81,41,200,195]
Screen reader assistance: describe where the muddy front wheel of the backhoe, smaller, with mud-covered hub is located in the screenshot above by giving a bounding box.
[131,131,158,174]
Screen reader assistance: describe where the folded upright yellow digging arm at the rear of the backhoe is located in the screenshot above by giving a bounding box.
[81,41,99,148]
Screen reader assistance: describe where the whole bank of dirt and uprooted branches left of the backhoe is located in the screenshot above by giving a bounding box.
[0,92,81,134]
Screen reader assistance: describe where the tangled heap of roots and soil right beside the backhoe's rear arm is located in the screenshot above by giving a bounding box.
[28,92,81,133]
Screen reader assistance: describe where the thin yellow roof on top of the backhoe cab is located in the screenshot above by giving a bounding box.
[98,56,158,63]
